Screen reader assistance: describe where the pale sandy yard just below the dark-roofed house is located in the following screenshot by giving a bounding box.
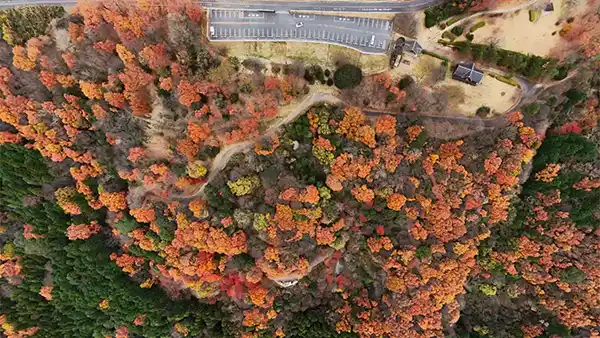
[433,76,520,116]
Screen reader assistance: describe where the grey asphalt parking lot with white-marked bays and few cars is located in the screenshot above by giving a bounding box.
[208,9,392,54]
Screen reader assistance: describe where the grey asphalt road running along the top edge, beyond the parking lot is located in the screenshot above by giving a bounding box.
[0,0,445,13]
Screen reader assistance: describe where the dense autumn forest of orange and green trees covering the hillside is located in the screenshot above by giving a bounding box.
[0,1,600,338]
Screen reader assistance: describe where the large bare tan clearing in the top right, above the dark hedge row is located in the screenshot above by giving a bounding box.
[472,0,563,56]
